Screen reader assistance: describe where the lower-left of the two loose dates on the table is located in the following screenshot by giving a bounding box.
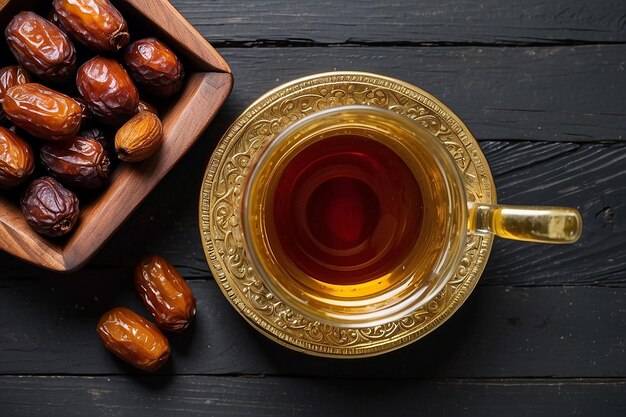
[96,307,170,371]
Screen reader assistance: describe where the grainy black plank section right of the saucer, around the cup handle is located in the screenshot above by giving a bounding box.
[483,142,626,286]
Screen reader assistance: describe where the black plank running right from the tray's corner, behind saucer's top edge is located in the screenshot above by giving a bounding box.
[214,45,626,142]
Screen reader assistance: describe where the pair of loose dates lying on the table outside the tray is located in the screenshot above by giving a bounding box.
[96,256,196,371]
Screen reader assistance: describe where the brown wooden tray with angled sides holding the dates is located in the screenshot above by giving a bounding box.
[0,0,233,271]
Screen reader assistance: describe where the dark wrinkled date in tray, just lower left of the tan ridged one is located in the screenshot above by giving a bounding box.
[40,136,110,188]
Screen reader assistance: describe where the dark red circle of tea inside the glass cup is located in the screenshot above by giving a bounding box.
[268,134,430,285]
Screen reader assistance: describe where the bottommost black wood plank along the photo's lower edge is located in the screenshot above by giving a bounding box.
[0,376,626,417]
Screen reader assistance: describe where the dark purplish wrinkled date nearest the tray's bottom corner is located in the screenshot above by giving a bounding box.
[21,177,80,237]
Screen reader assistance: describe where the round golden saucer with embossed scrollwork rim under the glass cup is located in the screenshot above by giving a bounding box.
[200,71,496,358]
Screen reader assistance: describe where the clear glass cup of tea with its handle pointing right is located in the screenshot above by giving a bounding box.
[241,105,582,328]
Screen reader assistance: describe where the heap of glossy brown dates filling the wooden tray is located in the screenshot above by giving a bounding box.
[0,0,185,237]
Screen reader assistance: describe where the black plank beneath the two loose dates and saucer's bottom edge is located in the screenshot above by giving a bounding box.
[0,280,626,376]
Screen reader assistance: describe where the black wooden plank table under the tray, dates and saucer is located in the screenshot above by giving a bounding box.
[0,0,626,417]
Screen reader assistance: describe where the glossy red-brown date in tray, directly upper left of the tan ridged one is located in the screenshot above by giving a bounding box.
[76,56,139,125]
